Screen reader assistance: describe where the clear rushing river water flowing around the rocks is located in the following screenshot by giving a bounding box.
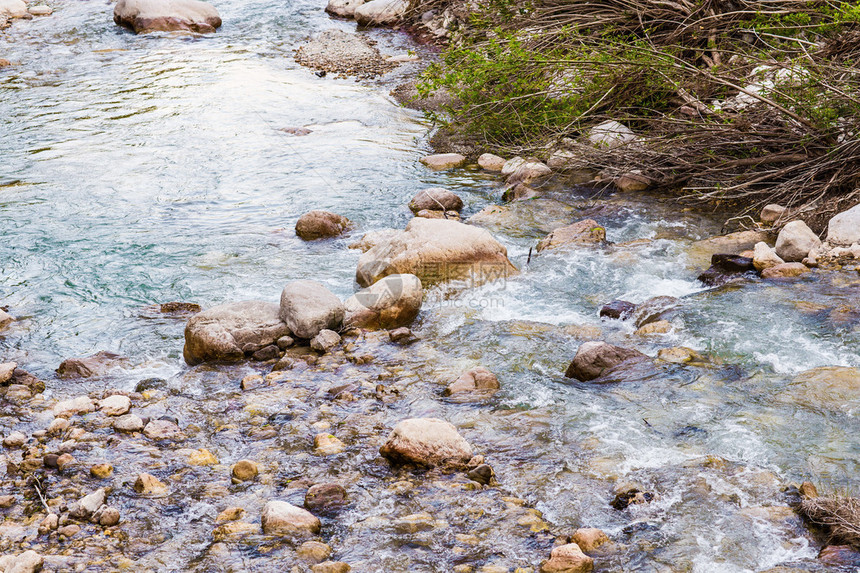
[0,0,860,572]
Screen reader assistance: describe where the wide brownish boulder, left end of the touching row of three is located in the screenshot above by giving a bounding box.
[182,300,290,366]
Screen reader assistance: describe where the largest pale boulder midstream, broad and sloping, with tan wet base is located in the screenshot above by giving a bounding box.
[355,217,518,286]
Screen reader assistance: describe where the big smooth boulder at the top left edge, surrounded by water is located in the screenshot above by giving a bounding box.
[113,0,221,34]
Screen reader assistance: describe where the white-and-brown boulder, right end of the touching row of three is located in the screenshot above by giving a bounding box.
[343,274,424,329]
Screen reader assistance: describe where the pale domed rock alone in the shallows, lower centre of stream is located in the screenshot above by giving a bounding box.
[379,418,472,466]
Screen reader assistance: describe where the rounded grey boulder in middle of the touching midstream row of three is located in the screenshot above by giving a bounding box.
[280,280,343,339]
